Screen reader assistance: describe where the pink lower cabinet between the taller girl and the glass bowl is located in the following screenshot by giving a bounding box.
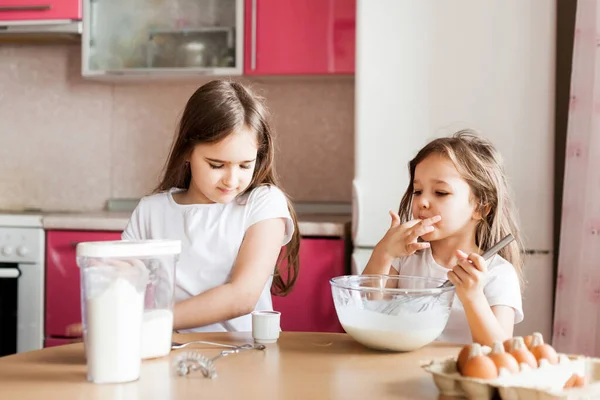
[273,238,347,332]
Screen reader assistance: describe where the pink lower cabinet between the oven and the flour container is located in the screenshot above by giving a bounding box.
[45,230,121,343]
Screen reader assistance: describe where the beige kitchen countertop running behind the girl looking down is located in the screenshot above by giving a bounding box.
[42,211,351,237]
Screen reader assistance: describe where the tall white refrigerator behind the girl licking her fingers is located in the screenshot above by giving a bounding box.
[351,0,556,342]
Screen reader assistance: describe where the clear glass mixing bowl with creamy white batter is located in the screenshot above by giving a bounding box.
[330,275,455,351]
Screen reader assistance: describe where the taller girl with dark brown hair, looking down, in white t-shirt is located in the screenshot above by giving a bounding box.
[122,80,299,331]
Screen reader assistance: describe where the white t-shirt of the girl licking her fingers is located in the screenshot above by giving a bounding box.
[392,248,523,344]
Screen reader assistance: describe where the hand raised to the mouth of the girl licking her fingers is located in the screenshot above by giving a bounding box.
[377,211,442,258]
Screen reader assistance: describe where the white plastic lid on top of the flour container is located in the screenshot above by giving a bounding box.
[77,240,181,258]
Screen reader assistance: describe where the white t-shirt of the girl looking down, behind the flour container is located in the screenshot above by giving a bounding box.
[122,186,294,332]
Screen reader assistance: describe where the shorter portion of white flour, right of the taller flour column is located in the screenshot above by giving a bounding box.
[142,309,173,359]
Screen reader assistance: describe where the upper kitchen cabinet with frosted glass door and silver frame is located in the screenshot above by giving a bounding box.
[81,0,244,78]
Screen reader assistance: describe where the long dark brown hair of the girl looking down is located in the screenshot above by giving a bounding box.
[155,80,300,296]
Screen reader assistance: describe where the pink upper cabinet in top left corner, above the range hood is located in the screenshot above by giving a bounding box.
[0,0,82,21]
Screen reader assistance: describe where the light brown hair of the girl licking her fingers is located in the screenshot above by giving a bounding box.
[399,129,524,283]
